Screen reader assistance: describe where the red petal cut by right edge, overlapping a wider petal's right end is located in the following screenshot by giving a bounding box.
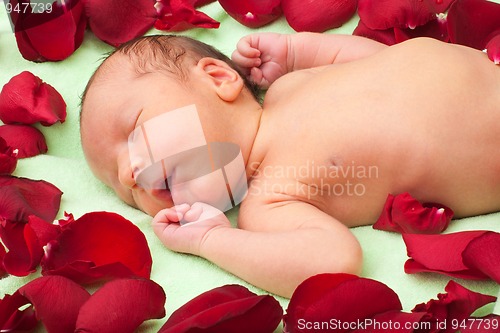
[462,232,500,284]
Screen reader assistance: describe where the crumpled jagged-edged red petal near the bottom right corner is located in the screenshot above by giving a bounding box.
[412,281,496,333]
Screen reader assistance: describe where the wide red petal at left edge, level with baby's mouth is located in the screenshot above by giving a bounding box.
[0,175,62,222]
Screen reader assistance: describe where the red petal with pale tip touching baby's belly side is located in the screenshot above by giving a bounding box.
[373,193,453,234]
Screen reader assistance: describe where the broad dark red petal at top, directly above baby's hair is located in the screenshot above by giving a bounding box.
[85,0,157,46]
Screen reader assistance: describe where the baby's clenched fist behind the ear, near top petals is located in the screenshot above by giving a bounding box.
[232,33,292,88]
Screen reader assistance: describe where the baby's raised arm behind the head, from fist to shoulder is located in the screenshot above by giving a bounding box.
[232,32,387,88]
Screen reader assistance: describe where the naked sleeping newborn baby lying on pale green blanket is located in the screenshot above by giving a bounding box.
[81,33,500,296]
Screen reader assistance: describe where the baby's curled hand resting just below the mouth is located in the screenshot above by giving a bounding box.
[152,202,231,255]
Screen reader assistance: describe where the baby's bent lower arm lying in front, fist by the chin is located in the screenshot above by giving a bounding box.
[153,198,361,297]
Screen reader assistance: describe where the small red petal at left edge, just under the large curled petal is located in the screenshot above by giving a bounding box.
[0,125,47,158]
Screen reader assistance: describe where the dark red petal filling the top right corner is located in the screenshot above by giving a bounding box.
[447,0,500,50]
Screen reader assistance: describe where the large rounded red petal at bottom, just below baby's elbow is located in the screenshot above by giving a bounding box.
[283,274,402,333]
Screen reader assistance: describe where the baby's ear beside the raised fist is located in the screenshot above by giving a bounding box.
[197,57,244,102]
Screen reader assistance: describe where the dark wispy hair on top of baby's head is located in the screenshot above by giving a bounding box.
[82,35,260,102]
